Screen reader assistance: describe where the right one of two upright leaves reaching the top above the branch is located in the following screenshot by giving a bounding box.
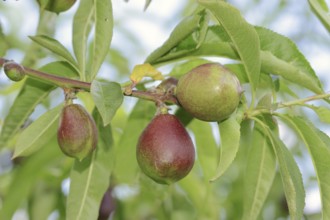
[89,0,113,80]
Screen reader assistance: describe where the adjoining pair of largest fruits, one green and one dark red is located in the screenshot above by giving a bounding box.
[136,63,242,184]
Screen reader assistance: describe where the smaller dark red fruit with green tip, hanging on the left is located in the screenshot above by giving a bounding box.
[57,104,98,160]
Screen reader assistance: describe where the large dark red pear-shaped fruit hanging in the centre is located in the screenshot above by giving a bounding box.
[136,114,195,184]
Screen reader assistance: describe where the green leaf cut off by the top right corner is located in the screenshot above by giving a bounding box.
[308,0,330,32]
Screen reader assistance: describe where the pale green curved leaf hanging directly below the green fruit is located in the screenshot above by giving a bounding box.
[210,114,240,181]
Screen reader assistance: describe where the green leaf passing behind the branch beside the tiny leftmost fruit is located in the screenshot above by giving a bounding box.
[0,62,76,148]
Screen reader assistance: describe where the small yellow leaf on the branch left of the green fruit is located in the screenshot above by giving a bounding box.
[130,63,164,83]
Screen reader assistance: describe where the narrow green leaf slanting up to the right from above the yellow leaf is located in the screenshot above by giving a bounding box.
[145,14,202,64]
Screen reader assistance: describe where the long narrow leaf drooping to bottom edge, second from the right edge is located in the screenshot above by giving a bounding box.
[268,126,305,220]
